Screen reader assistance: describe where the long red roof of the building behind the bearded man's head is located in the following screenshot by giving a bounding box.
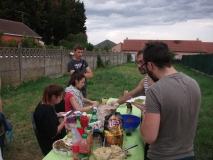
[122,39,210,53]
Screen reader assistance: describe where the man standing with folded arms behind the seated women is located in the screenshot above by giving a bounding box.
[67,44,93,98]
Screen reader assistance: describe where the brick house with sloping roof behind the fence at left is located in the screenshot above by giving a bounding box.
[0,19,42,43]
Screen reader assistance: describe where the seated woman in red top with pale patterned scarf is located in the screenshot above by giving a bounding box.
[64,71,99,112]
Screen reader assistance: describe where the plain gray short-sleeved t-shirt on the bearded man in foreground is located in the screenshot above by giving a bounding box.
[146,73,201,160]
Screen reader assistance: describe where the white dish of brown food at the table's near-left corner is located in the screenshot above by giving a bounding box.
[52,139,73,156]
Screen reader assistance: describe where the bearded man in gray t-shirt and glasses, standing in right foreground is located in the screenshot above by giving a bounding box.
[140,42,201,160]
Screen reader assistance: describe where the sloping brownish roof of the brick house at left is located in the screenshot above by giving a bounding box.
[0,19,42,38]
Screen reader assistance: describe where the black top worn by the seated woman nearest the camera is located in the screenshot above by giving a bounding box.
[34,103,66,151]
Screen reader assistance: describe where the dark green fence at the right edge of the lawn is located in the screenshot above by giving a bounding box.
[182,54,213,75]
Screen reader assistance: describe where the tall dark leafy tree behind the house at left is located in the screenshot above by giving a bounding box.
[0,0,86,45]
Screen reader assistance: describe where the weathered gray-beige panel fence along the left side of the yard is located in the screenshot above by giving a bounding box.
[0,47,127,86]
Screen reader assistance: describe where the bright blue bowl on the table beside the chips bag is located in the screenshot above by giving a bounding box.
[121,114,141,130]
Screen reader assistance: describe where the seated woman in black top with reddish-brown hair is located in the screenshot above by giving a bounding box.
[34,84,66,154]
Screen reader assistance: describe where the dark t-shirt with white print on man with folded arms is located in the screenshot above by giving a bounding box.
[67,59,89,90]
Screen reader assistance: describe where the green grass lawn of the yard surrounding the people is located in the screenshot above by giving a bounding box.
[1,63,213,160]
